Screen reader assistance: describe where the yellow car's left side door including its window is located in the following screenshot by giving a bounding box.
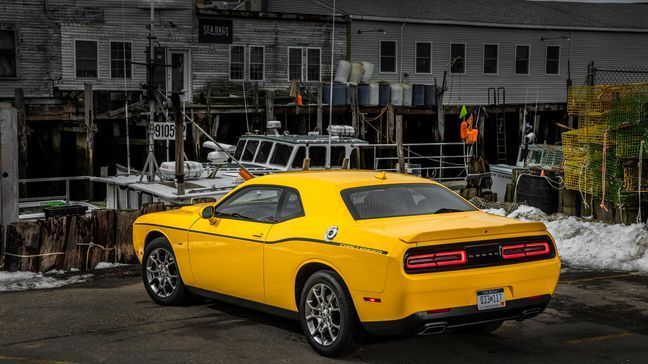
[189,186,282,302]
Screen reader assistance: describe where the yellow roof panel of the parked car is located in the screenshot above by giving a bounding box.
[248,170,436,190]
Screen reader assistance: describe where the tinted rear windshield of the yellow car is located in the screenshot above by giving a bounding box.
[342,183,475,220]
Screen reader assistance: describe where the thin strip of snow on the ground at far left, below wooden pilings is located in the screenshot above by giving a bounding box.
[0,271,92,292]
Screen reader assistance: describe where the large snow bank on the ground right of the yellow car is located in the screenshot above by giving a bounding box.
[484,205,648,272]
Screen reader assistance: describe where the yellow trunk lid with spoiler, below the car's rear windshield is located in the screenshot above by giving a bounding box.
[360,211,547,243]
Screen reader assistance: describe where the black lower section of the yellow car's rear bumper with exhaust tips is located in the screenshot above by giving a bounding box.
[362,295,551,335]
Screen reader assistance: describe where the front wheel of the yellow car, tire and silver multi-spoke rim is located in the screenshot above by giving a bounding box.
[142,238,192,306]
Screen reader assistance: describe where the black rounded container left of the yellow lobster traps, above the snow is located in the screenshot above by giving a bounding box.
[515,174,558,214]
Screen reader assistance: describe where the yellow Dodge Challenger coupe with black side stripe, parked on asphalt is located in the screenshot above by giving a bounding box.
[133,170,560,356]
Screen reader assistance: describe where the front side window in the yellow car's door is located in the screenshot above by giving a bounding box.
[216,187,282,222]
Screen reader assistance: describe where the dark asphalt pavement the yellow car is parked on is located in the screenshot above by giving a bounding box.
[0,267,648,364]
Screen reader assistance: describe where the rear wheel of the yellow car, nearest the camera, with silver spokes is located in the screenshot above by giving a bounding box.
[299,271,358,358]
